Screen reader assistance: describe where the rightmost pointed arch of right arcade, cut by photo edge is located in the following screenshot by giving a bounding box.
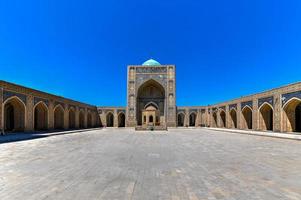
[282,97,301,132]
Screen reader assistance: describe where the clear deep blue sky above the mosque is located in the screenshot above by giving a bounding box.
[0,0,301,106]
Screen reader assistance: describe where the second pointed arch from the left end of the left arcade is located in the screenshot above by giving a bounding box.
[33,101,49,131]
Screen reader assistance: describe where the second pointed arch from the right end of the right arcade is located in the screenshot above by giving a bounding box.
[259,102,274,131]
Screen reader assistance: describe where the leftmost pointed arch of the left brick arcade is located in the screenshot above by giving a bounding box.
[3,96,26,132]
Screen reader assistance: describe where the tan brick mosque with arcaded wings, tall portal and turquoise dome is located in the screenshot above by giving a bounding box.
[0,59,301,133]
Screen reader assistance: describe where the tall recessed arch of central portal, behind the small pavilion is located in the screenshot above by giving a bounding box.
[136,79,165,126]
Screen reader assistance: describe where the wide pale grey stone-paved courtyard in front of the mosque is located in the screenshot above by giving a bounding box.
[0,129,301,200]
